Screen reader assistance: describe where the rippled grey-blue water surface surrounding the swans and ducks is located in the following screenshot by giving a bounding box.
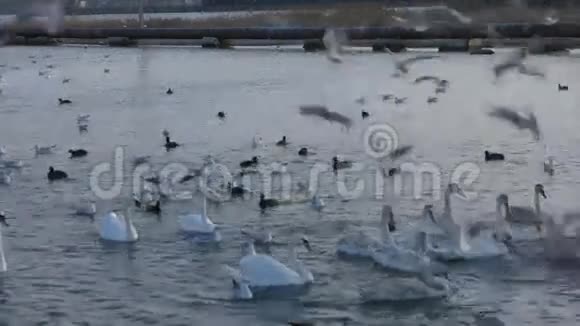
[0,47,580,325]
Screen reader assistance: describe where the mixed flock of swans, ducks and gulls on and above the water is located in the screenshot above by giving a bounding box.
[0,44,580,326]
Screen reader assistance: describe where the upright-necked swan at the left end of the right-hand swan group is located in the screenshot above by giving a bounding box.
[336,205,395,257]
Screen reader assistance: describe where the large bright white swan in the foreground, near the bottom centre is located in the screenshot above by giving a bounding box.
[230,238,314,288]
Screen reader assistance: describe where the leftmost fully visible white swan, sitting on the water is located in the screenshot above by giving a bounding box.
[97,209,139,242]
